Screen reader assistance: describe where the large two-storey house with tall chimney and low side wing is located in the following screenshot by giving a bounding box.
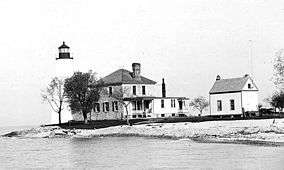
[73,63,189,120]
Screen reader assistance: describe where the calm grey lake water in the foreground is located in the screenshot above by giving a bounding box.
[0,126,284,169]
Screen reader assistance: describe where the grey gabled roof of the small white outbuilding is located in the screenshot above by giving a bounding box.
[209,76,258,94]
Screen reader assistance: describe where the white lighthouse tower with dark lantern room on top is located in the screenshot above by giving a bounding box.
[51,41,74,124]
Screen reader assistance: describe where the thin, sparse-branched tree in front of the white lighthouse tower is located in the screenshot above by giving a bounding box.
[41,77,66,124]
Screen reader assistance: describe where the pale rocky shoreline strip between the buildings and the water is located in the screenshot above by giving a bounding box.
[2,119,284,146]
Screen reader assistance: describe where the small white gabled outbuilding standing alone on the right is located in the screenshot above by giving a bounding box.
[209,74,258,116]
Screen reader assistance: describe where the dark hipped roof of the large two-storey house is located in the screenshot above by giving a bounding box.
[101,69,156,85]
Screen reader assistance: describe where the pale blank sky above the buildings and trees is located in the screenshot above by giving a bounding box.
[0,0,284,126]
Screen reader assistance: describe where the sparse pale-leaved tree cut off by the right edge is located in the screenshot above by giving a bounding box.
[273,49,284,90]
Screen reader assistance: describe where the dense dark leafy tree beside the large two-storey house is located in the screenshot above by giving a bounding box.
[64,71,101,123]
